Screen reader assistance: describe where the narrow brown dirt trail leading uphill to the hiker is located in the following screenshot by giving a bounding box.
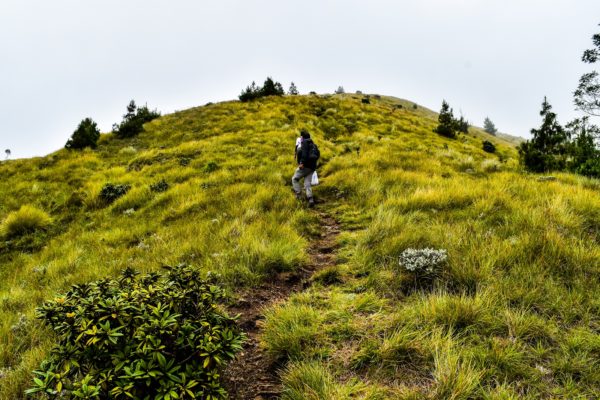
[224,206,340,400]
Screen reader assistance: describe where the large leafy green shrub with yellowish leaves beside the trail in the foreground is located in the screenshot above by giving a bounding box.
[27,265,244,399]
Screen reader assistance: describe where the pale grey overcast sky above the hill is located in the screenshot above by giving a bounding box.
[0,0,600,158]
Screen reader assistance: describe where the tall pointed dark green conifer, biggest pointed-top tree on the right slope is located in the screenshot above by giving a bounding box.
[519,97,569,172]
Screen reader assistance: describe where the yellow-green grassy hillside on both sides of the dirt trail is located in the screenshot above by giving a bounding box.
[0,95,600,399]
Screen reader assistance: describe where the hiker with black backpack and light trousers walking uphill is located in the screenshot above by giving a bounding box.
[292,129,320,207]
